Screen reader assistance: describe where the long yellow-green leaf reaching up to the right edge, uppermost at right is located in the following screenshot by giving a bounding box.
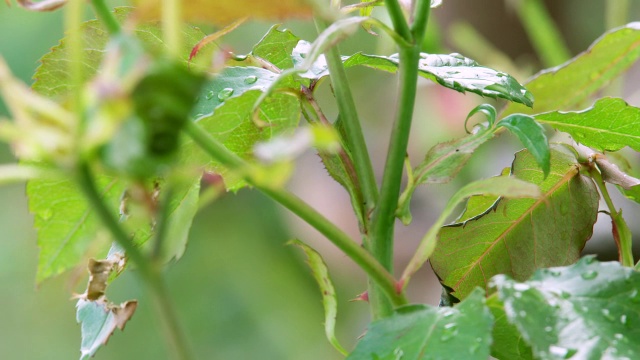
[503,22,640,116]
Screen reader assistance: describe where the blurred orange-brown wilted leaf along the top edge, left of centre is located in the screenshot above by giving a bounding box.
[134,0,314,25]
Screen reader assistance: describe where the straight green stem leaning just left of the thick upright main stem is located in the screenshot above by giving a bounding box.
[316,19,378,217]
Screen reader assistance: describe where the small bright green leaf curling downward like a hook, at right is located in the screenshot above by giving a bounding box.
[496,114,551,177]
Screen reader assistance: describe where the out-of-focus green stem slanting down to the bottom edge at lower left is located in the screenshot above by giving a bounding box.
[77,163,192,360]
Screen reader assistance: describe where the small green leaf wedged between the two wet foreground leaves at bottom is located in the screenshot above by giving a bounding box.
[487,294,533,360]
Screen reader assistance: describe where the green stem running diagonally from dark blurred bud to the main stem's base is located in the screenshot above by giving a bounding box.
[185,122,407,306]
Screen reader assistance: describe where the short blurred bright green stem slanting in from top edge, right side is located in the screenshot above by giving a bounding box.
[517,0,571,67]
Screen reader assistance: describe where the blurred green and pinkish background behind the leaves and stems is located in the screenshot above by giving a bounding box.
[0,0,640,360]
